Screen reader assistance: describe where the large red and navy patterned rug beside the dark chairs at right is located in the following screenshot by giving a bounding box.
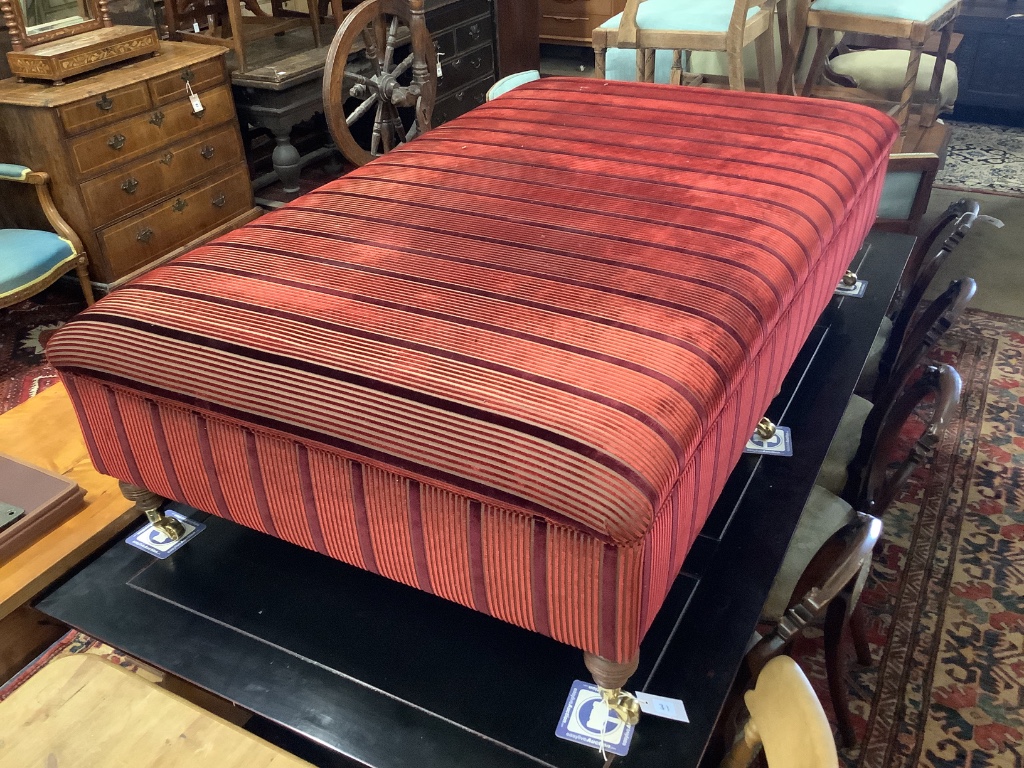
[795,311,1024,768]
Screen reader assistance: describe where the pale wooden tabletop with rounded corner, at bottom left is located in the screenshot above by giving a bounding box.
[0,654,309,768]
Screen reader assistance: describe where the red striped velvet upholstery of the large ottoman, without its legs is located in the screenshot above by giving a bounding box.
[47,79,896,660]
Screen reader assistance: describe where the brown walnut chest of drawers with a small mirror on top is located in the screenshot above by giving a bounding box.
[0,42,259,285]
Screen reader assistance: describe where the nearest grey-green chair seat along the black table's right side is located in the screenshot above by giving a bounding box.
[761,485,855,624]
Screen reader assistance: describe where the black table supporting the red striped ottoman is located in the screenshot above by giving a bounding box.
[38,232,913,768]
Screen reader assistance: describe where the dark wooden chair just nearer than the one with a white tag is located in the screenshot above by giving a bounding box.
[815,278,975,503]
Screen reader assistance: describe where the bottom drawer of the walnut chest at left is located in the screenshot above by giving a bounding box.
[96,165,252,274]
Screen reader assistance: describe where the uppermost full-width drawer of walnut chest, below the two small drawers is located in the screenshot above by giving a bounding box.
[69,85,234,175]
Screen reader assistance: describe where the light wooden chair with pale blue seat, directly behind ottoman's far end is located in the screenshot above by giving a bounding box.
[593,0,787,93]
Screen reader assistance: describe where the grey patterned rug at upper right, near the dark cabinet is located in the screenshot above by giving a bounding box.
[935,121,1024,197]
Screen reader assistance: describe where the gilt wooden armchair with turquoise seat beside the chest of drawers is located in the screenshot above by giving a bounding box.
[0,163,92,307]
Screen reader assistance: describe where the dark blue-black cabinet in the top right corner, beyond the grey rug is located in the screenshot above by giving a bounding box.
[952,0,1024,112]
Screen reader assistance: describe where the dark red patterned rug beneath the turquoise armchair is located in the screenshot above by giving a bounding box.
[0,281,85,414]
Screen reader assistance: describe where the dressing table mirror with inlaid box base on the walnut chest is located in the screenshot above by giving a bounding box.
[0,0,160,85]
